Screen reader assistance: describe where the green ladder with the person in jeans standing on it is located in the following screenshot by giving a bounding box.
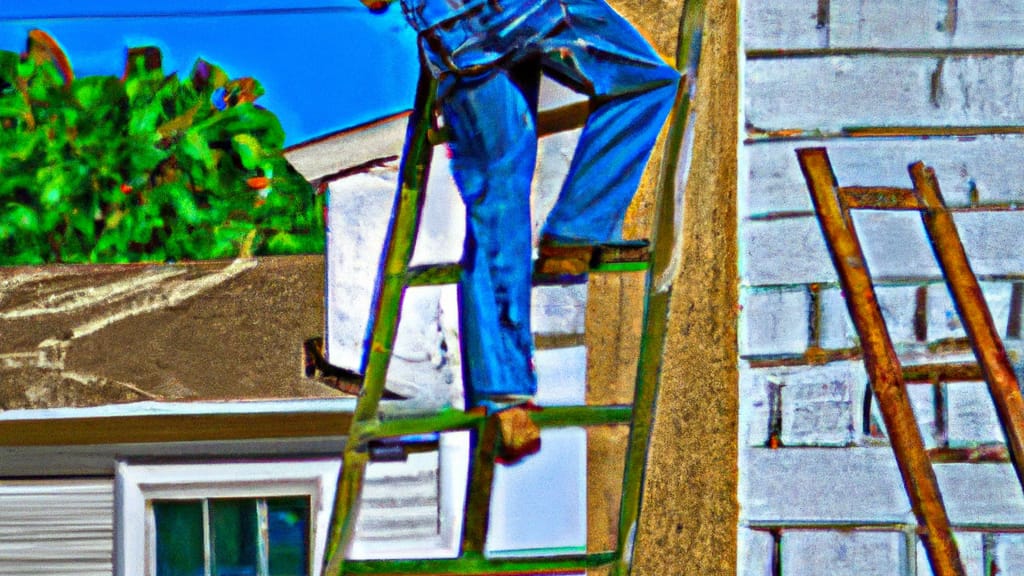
[323,0,703,576]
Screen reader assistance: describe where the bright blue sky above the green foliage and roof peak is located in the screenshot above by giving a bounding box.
[0,0,417,145]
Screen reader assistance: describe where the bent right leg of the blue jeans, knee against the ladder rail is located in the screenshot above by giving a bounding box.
[539,0,679,242]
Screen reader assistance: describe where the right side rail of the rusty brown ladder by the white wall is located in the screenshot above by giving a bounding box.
[909,162,1024,494]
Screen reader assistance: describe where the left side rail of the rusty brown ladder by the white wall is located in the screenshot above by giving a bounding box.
[797,149,965,576]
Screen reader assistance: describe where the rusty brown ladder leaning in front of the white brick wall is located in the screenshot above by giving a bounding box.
[797,148,1024,576]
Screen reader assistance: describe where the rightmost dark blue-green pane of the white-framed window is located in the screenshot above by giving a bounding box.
[266,498,309,576]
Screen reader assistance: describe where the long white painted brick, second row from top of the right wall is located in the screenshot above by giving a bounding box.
[744,54,1024,130]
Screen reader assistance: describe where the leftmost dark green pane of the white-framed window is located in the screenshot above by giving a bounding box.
[153,500,204,576]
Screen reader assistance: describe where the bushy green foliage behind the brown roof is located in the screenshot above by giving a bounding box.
[0,31,324,264]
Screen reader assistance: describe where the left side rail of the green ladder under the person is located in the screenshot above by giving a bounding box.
[324,64,436,576]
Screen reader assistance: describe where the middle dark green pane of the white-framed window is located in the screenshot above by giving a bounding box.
[210,499,259,576]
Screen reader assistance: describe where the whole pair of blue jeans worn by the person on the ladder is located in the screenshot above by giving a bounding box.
[403,0,679,406]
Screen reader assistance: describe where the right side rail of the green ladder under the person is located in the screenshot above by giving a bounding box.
[610,0,705,576]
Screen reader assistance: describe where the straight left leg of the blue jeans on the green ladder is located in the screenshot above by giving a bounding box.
[440,69,537,406]
